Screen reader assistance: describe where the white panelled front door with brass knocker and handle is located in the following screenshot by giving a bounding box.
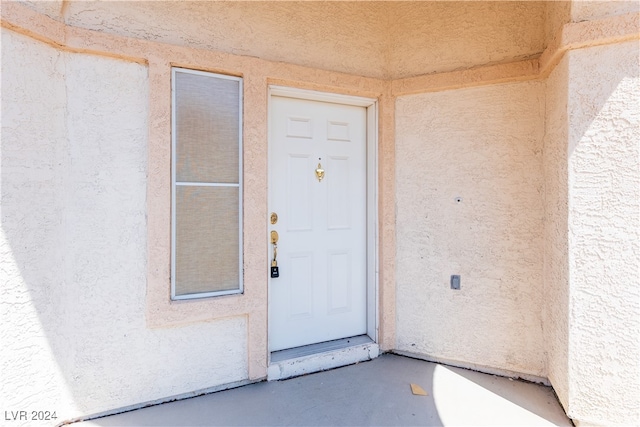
[269,96,367,351]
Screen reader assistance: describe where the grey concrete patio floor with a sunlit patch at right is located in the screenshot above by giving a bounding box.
[76,354,572,427]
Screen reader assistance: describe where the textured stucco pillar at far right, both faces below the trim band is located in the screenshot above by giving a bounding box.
[544,23,640,425]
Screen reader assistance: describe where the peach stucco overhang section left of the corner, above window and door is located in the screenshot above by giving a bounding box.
[66,1,386,77]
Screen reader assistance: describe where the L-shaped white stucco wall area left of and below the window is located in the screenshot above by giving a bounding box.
[0,30,247,421]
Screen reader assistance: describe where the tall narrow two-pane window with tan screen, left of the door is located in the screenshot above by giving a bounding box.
[171,68,243,299]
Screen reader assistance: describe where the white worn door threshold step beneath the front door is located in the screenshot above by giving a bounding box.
[267,335,380,381]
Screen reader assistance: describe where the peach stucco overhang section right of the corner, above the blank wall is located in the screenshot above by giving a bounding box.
[387,1,545,79]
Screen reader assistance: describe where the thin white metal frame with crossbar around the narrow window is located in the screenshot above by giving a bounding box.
[171,67,244,300]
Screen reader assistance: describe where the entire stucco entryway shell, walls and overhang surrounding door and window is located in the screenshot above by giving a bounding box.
[1,1,640,424]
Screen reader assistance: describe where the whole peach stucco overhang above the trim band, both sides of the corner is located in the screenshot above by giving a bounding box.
[17,1,545,78]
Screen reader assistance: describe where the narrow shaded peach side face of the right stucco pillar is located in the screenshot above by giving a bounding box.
[543,51,569,409]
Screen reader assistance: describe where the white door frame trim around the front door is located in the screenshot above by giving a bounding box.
[265,85,379,363]
